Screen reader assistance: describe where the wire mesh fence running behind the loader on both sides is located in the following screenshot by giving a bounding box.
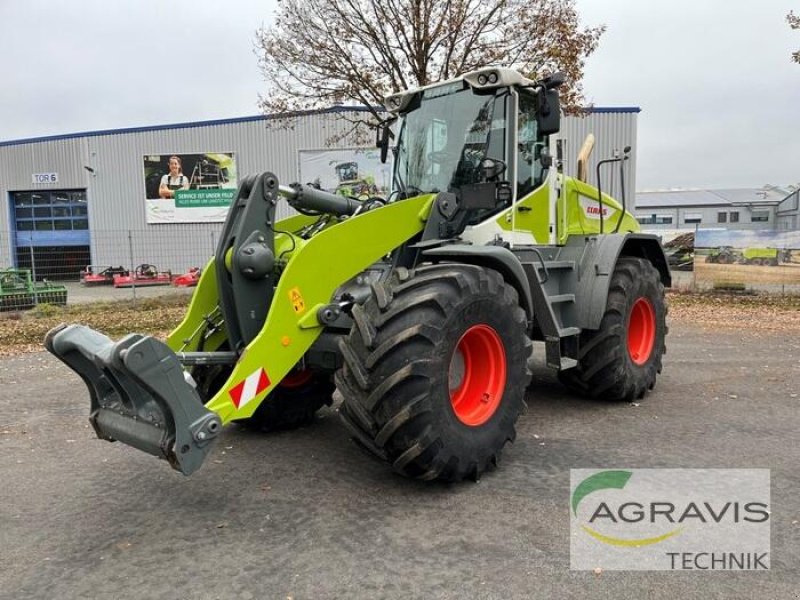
[0,223,800,312]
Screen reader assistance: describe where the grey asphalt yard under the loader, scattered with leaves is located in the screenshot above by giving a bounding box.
[0,320,800,600]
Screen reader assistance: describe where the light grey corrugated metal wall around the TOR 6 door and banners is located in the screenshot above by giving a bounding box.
[0,111,637,270]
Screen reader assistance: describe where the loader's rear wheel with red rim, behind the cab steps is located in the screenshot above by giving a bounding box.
[558,256,668,401]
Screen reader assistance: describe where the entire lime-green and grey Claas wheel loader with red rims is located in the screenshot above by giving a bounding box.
[45,68,671,481]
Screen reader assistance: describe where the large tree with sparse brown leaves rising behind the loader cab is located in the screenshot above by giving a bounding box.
[256,0,605,140]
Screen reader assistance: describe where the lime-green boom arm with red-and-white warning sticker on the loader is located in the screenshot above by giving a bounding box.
[198,174,432,424]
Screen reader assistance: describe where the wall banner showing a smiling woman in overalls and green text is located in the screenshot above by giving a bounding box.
[143,152,238,223]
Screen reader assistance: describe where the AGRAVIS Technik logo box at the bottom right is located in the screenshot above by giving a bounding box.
[569,469,770,570]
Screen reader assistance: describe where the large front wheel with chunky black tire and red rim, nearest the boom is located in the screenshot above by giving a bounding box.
[336,264,531,481]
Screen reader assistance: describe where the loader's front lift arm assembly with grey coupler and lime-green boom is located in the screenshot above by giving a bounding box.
[45,173,431,475]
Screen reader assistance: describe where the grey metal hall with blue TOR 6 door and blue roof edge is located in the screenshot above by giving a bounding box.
[0,107,636,279]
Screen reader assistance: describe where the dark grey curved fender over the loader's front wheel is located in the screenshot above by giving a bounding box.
[422,244,533,322]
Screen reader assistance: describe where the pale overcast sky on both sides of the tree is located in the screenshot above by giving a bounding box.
[0,0,800,189]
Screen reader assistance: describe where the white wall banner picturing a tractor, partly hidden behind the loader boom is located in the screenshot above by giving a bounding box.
[300,148,392,199]
